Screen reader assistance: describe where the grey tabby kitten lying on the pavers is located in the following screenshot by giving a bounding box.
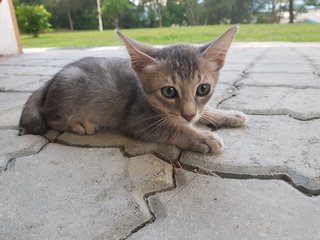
[20,27,246,153]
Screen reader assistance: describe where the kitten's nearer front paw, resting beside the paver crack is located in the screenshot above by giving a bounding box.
[189,131,223,153]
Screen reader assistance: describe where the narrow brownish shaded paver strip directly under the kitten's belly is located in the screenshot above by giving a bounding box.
[57,131,181,162]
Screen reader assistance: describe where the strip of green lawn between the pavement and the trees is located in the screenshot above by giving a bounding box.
[21,24,320,48]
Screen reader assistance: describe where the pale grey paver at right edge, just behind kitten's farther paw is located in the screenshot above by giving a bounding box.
[220,86,320,120]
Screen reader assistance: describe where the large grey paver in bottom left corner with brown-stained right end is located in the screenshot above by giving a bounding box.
[0,144,173,240]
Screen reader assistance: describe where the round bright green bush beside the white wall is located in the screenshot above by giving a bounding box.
[16,4,51,37]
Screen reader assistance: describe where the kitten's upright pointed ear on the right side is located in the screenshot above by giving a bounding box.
[200,26,239,70]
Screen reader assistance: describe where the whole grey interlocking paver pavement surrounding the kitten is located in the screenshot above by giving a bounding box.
[0,43,320,240]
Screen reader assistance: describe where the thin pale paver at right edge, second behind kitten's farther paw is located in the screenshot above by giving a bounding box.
[236,73,320,89]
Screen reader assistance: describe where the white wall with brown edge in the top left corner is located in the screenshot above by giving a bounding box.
[0,0,22,55]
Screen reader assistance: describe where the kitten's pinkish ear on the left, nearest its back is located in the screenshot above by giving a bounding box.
[116,30,157,72]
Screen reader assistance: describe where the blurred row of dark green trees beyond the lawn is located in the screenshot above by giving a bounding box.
[14,0,320,30]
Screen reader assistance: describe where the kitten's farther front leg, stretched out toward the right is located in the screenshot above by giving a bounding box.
[199,109,247,129]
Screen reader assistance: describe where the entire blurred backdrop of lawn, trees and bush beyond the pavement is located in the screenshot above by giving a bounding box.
[6,0,320,47]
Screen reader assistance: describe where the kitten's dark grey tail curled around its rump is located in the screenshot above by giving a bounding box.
[19,82,50,135]
